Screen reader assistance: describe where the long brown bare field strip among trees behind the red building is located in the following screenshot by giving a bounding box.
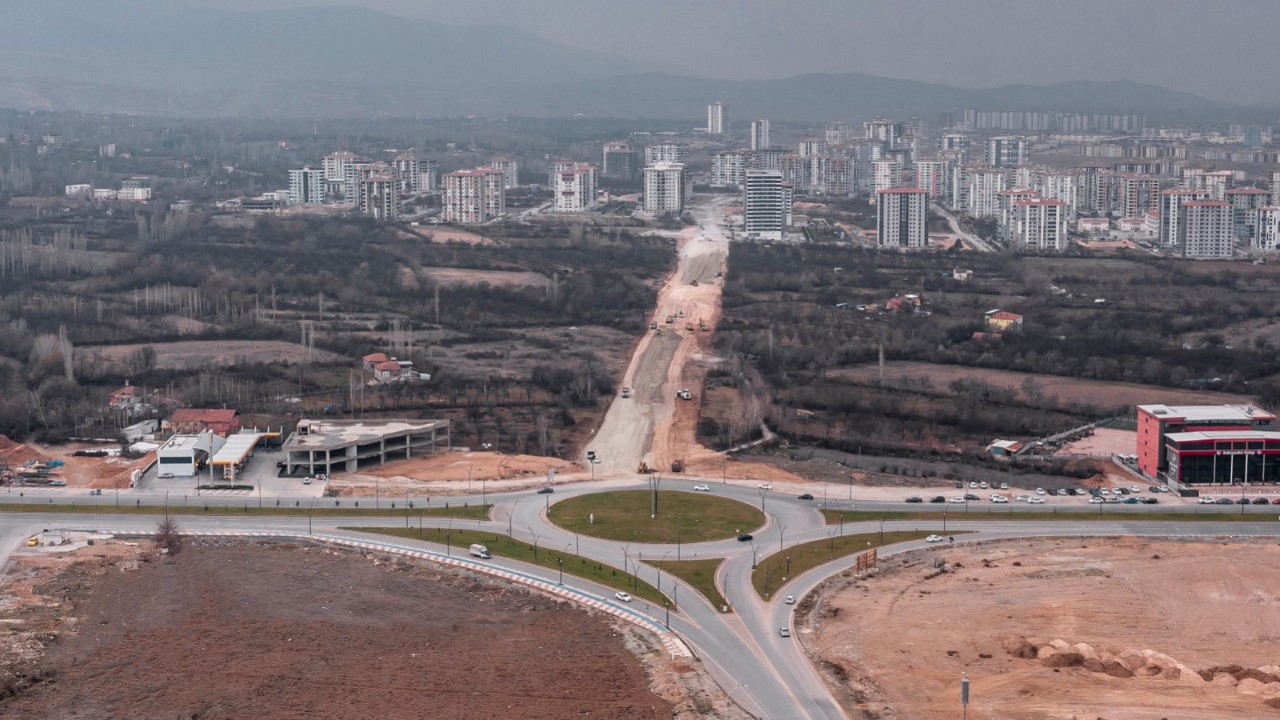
[831,361,1252,407]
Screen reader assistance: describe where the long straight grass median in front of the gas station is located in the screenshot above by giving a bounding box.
[0,500,493,520]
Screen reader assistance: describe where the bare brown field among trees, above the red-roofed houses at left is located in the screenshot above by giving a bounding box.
[77,340,342,370]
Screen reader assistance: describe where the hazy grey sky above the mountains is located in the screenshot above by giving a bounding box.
[199,0,1280,105]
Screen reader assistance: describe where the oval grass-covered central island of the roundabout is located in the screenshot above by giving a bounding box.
[547,489,764,544]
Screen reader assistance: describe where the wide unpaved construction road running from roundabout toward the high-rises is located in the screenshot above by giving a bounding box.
[588,200,728,475]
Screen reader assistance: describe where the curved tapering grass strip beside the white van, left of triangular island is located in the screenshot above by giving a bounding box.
[343,520,668,606]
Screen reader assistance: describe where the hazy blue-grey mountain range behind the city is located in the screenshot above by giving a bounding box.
[0,0,1257,124]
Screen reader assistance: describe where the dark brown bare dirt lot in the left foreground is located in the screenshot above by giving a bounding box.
[0,541,691,720]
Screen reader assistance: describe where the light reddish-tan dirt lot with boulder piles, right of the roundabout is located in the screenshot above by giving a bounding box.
[797,538,1280,720]
